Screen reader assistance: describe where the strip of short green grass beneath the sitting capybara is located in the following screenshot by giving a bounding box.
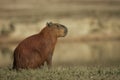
[0,66,120,80]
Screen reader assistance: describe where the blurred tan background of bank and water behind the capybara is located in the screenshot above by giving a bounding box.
[0,0,120,67]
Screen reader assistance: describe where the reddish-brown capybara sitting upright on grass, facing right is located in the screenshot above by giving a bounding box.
[13,22,68,69]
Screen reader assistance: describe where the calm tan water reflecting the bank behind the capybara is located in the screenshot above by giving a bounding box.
[0,41,120,67]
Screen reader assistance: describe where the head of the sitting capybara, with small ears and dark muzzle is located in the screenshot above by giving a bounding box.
[47,22,68,37]
